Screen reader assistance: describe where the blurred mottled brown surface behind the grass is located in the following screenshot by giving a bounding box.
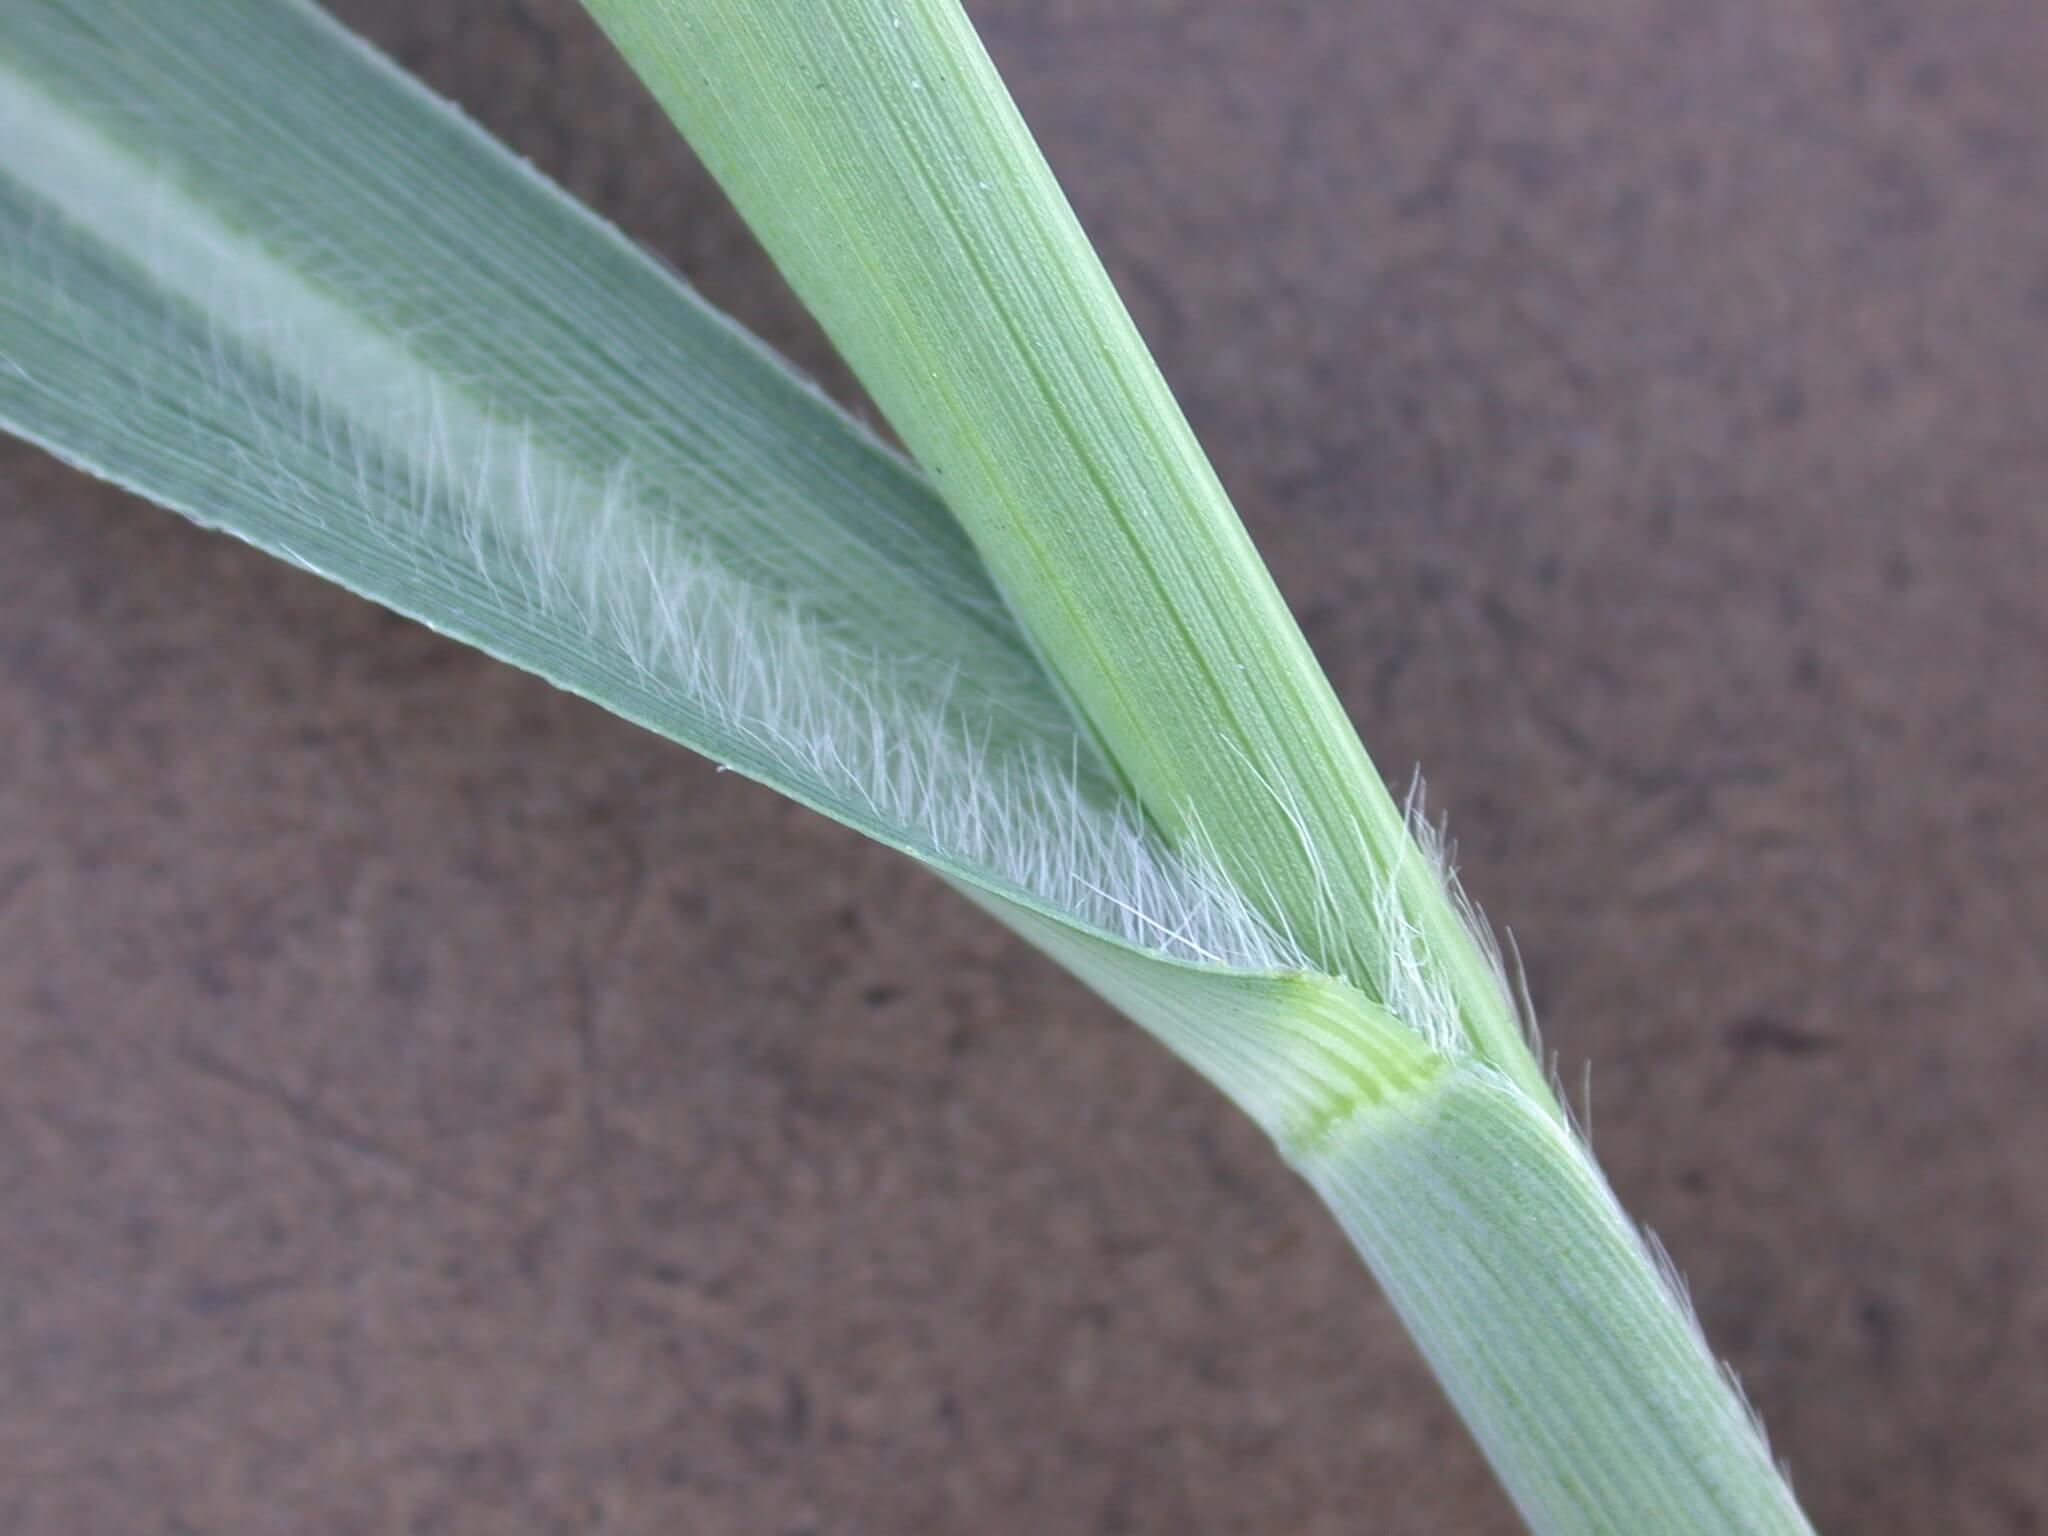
[0,0,2048,1536]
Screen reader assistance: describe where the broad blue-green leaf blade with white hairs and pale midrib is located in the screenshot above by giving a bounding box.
[0,0,1458,1133]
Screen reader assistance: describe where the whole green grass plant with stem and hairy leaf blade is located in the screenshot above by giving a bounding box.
[0,0,1806,1536]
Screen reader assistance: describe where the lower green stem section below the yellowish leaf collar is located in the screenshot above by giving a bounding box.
[1294,1067,1810,1536]
